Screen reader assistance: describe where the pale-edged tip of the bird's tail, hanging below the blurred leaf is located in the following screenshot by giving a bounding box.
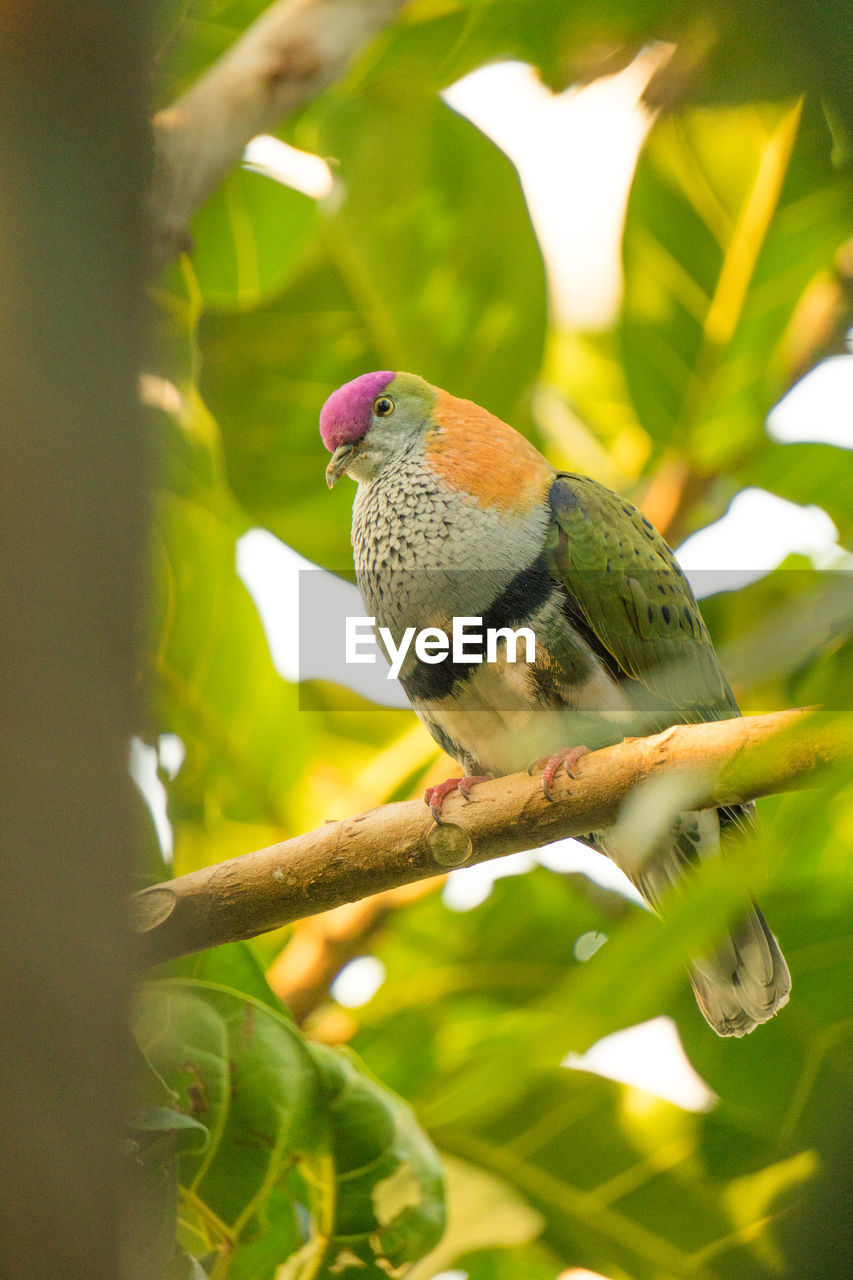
[690,906,790,1036]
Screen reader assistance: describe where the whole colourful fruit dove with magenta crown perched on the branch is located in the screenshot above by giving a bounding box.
[320,370,790,1037]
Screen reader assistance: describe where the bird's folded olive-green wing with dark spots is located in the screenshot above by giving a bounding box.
[547,472,738,724]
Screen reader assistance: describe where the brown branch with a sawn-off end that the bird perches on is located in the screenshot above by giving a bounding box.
[132,710,853,964]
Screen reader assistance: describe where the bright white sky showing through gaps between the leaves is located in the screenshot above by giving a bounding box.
[132,55,853,1152]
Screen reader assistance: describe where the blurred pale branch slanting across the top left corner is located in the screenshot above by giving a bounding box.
[151,0,405,266]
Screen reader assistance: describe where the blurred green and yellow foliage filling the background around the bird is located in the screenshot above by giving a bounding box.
[142,0,853,1280]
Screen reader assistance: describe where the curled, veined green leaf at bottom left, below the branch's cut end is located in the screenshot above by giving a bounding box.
[134,978,444,1280]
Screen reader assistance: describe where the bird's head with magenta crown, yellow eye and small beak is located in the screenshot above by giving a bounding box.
[320,370,437,489]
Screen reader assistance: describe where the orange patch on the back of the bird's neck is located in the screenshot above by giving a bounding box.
[425,390,555,515]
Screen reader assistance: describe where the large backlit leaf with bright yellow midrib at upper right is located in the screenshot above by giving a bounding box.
[620,105,853,472]
